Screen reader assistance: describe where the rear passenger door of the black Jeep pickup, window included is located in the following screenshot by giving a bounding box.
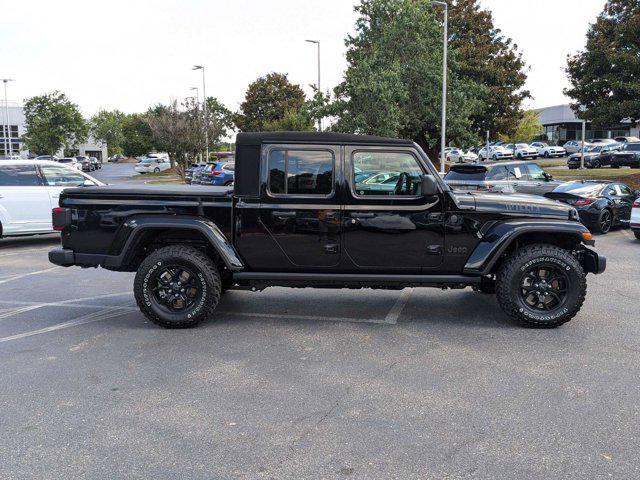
[259,144,342,269]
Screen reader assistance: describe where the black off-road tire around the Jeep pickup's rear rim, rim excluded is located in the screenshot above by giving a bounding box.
[133,245,221,328]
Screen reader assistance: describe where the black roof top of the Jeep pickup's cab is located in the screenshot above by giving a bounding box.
[236,132,413,146]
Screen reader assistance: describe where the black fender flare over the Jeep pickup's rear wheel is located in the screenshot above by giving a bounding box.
[104,215,244,271]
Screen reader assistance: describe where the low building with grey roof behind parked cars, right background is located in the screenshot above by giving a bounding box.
[536,104,640,145]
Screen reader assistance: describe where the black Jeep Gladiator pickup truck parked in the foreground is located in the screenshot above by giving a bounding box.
[49,132,606,328]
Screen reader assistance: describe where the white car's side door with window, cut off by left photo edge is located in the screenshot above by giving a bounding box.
[0,164,52,235]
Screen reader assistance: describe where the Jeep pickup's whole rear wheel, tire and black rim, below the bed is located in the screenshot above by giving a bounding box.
[133,245,221,328]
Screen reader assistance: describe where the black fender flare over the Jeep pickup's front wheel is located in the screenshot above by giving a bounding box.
[463,219,594,275]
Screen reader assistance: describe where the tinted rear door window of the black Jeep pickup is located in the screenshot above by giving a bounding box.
[269,149,334,195]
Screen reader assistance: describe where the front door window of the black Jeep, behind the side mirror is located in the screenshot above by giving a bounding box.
[351,151,424,196]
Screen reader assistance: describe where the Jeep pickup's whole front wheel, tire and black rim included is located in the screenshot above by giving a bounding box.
[496,244,587,328]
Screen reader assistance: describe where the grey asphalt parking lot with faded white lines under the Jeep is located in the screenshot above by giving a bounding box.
[0,230,640,479]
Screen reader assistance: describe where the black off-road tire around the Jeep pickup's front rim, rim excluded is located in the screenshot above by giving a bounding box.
[496,244,587,328]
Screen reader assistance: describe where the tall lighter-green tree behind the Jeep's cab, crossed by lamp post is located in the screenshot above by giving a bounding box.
[326,0,486,157]
